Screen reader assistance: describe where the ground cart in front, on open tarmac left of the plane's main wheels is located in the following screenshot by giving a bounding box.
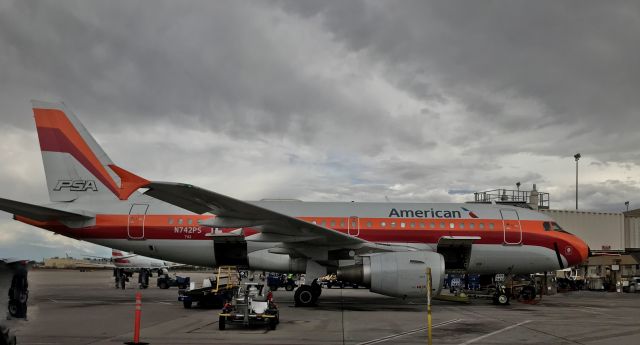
[218,282,280,330]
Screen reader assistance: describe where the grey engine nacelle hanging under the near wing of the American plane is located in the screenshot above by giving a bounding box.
[337,251,444,298]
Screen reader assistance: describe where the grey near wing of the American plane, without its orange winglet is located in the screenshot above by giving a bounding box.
[145,182,374,247]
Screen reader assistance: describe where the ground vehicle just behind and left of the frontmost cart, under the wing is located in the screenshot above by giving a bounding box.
[178,266,240,309]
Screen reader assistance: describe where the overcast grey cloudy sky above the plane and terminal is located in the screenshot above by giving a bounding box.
[0,0,640,258]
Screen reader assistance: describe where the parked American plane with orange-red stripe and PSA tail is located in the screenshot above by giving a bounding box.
[0,101,588,306]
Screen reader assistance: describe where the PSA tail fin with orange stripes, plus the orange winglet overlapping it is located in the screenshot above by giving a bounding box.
[32,101,149,201]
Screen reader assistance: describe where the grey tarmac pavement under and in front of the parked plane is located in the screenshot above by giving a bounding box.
[8,270,640,345]
